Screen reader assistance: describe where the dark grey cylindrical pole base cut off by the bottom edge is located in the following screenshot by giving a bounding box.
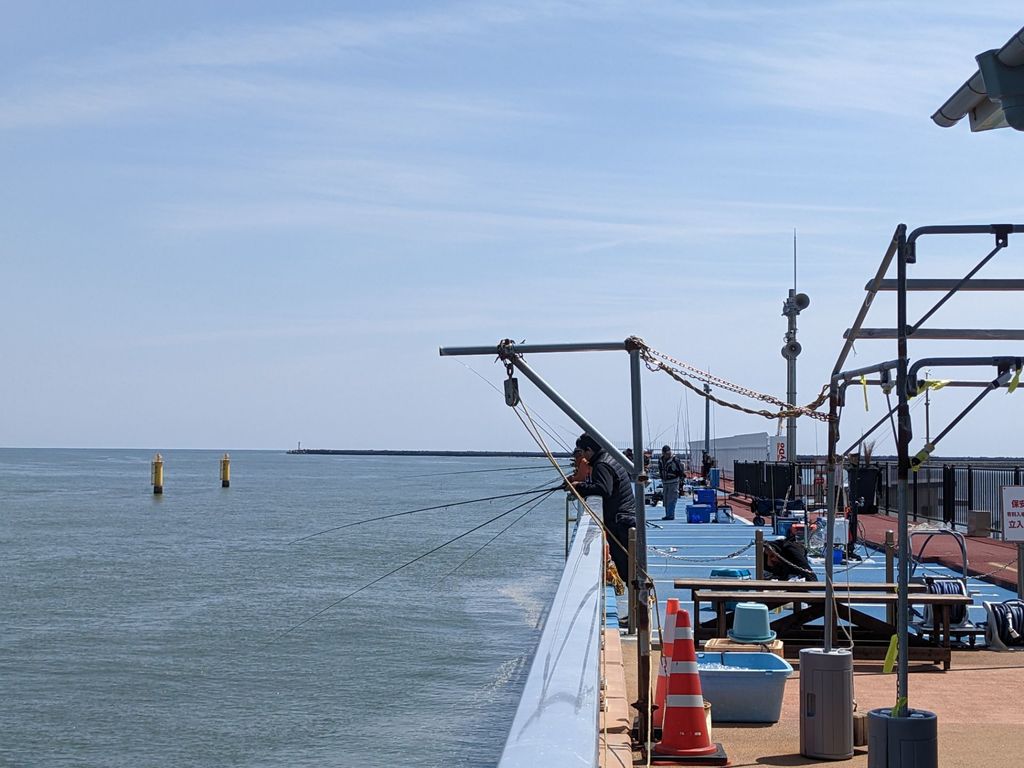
[867,708,939,768]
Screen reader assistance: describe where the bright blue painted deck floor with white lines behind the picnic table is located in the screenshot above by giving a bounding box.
[647,501,1017,644]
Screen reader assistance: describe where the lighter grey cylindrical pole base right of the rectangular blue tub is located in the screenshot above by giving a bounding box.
[800,648,853,760]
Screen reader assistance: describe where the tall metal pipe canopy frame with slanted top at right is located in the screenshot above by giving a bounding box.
[824,224,1024,714]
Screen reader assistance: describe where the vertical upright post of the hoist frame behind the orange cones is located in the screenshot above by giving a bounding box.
[624,348,650,749]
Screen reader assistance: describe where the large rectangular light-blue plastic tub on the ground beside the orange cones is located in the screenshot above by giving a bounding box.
[697,651,793,723]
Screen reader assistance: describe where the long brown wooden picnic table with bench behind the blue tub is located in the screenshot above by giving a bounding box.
[691,593,973,670]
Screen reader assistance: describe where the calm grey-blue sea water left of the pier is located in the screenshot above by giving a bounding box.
[0,450,564,767]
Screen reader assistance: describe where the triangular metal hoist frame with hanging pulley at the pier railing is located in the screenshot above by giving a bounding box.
[438,339,652,745]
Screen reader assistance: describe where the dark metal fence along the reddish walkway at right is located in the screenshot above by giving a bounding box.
[733,461,1024,539]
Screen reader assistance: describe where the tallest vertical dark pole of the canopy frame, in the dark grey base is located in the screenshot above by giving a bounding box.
[896,229,912,711]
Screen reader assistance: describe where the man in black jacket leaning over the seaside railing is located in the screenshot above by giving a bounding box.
[573,433,637,581]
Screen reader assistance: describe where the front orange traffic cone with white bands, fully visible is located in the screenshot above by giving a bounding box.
[652,608,729,765]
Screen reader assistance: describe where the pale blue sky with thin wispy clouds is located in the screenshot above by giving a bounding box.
[0,0,1024,456]
